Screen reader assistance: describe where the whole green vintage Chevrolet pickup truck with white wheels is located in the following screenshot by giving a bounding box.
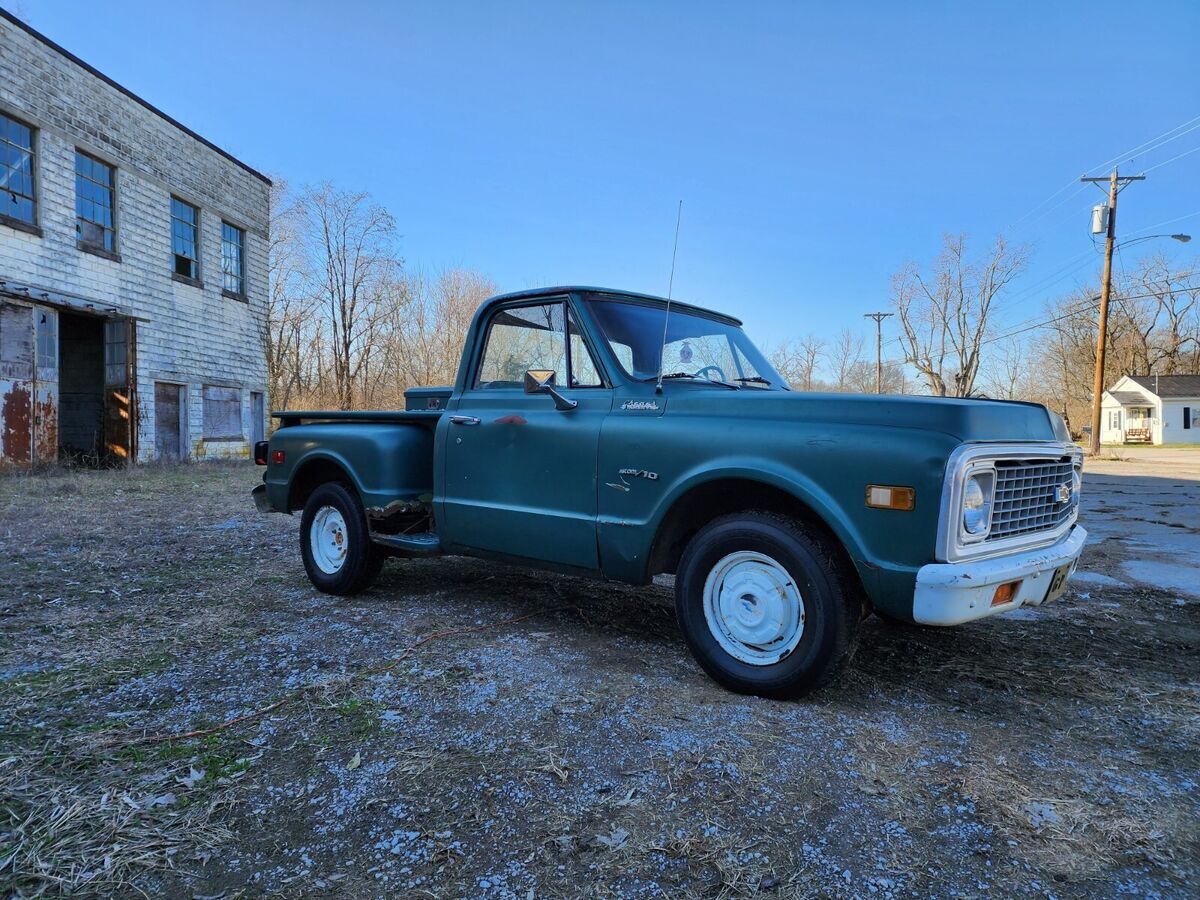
[254,287,1086,697]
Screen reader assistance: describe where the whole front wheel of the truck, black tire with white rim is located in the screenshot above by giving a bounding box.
[676,512,862,700]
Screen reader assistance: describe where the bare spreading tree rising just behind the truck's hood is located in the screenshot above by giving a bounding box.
[892,234,1027,397]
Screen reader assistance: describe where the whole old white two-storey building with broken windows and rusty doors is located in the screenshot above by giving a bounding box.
[0,10,270,464]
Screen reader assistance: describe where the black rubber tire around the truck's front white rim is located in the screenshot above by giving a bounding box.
[676,512,863,700]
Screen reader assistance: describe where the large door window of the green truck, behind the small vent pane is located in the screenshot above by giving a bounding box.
[475,304,566,389]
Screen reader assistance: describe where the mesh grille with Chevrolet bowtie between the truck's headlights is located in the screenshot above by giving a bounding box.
[988,456,1079,541]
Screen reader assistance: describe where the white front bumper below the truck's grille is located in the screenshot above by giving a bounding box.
[912,526,1087,625]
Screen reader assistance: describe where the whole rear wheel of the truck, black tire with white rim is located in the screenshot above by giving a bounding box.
[300,481,388,596]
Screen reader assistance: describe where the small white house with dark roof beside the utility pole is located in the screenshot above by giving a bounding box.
[1100,376,1200,444]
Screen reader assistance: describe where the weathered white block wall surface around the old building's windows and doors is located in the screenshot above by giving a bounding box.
[0,18,270,460]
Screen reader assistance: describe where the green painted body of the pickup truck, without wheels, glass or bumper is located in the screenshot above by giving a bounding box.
[264,288,1068,618]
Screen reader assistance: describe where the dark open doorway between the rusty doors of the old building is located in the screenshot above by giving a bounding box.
[59,312,104,462]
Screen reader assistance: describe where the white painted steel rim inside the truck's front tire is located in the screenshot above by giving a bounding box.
[704,550,804,666]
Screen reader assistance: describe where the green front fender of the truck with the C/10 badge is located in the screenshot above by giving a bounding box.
[598,421,958,601]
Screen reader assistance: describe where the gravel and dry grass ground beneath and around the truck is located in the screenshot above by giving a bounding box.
[0,454,1200,898]
